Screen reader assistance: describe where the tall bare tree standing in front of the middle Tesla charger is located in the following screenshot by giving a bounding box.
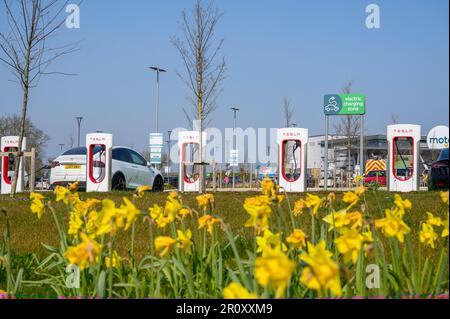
[172,0,226,192]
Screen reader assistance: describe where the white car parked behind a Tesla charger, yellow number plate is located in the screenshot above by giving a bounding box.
[50,146,164,192]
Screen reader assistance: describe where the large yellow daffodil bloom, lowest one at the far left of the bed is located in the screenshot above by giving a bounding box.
[64,233,101,270]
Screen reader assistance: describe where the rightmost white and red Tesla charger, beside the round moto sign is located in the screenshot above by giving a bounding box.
[387,124,421,192]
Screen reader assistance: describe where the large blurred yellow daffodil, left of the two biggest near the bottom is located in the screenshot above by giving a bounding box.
[255,249,295,298]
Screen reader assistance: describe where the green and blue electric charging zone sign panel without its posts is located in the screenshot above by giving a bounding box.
[323,94,366,115]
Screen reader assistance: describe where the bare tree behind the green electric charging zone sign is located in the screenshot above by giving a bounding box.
[334,81,361,186]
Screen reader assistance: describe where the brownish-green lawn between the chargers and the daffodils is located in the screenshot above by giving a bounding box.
[0,190,446,257]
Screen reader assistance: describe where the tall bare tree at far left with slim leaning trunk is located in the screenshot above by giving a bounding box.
[0,0,79,196]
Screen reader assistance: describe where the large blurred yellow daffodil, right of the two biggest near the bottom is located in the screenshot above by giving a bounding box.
[300,241,342,296]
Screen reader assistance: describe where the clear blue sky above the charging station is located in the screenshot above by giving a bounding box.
[0,0,449,157]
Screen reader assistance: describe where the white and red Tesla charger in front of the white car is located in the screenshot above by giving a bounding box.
[86,133,113,192]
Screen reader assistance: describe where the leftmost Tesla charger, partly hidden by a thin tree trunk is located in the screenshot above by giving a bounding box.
[1,136,27,194]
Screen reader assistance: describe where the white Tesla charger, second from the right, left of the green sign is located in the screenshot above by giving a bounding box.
[277,128,308,192]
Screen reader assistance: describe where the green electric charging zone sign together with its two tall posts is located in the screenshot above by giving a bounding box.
[323,94,366,190]
